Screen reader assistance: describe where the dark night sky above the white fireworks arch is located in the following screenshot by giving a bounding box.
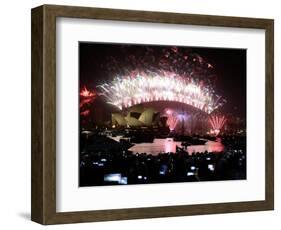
[79,43,246,119]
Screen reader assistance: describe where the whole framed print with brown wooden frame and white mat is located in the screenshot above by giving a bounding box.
[31,5,274,224]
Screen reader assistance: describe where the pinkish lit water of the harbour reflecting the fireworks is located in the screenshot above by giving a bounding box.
[129,138,224,155]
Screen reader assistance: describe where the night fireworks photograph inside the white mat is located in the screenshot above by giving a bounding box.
[77,42,247,187]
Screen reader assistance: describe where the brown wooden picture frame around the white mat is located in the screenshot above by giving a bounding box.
[31,5,274,224]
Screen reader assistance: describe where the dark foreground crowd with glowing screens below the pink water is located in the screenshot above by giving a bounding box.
[79,135,246,186]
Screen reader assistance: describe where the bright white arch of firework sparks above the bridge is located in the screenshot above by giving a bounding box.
[98,74,223,113]
